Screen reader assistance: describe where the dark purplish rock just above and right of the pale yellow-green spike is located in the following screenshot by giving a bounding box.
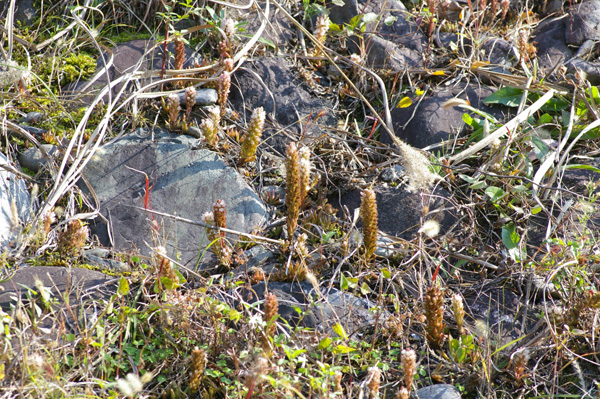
[229,57,336,155]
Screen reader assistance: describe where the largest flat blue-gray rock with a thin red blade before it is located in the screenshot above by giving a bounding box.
[82,133,266,267]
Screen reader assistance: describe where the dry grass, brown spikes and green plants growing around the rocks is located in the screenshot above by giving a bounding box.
[0,0,600,398]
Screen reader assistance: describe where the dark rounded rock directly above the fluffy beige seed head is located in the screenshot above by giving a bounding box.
[390,86,503,148]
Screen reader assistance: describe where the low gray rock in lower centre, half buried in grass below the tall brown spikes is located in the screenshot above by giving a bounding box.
[237,281,388,335]
